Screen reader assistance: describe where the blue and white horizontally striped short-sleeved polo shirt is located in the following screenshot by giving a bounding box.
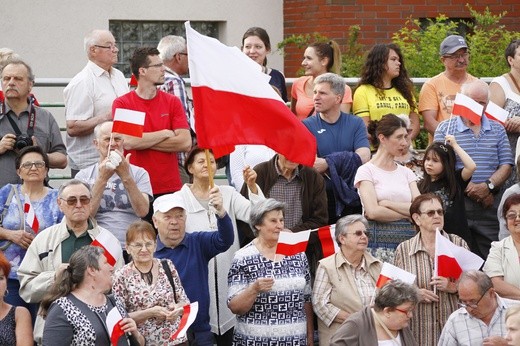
[434,116,514,183]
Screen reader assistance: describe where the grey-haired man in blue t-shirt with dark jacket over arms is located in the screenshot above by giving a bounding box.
[303,73,370,224]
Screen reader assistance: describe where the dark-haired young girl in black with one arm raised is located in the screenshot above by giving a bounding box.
[418,135,477,249]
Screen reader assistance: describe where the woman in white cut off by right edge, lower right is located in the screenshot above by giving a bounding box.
[483,194,520,300]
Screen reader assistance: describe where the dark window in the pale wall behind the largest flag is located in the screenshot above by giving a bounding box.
[109,20,219,77]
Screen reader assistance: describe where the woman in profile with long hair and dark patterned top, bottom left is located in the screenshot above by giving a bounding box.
[41,245,144,346]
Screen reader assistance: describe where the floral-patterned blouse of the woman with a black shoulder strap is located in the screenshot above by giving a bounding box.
[112,259,190,345]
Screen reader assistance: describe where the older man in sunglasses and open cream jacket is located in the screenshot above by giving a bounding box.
[18,179,123,342]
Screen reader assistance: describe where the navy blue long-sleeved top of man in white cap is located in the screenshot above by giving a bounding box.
[154,214,235,333]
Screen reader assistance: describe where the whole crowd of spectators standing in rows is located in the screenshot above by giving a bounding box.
[0,27,520,346]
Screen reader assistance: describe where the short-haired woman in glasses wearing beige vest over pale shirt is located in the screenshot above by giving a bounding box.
[312,215,381,346]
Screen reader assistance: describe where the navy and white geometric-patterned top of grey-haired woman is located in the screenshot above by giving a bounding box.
[228,242,311,346]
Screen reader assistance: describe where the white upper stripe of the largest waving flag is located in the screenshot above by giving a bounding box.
[184,22,283,102]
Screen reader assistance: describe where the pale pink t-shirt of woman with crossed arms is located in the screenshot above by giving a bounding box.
[354,162,417,203]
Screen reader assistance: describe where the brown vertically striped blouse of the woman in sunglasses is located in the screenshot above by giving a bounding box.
[394,231,469,346]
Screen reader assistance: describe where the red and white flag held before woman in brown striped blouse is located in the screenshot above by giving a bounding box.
[435,231,484,280]
